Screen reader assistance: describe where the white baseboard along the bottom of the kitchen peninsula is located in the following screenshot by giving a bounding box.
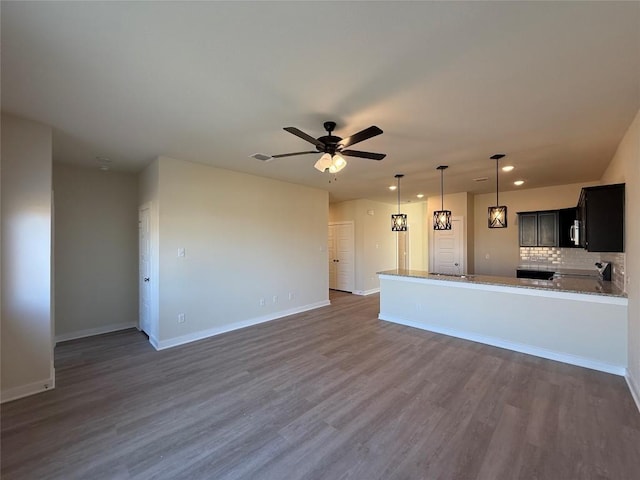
[378,313,626,376]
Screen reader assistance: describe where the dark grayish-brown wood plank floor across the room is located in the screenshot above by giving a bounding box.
[1,292,640,480]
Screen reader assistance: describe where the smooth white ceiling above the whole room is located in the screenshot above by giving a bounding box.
[1,1,640,203]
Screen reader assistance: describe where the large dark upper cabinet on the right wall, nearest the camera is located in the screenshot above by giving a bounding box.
[578,183,624,252]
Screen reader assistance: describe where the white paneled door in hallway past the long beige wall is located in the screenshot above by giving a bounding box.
[329,222,355,292]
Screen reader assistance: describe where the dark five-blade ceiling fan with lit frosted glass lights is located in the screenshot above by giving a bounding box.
[255,122,386,173]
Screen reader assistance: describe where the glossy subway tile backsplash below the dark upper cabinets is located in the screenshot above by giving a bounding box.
[520,247,625,290]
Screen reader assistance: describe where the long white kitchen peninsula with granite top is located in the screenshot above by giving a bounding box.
[378,270,628,375]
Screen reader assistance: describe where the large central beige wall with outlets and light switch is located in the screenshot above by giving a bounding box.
[141,157,329,348]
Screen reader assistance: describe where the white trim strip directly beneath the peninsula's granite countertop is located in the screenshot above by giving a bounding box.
[378,273,629,307]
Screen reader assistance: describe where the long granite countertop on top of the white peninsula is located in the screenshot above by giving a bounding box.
[378,269,627,298]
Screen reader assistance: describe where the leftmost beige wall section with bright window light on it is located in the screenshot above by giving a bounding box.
[1,114,55,401]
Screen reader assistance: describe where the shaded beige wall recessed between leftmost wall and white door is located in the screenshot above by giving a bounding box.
[53,164,138,341]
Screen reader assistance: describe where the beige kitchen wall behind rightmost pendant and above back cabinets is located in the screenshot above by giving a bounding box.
[474,182,593,277]
